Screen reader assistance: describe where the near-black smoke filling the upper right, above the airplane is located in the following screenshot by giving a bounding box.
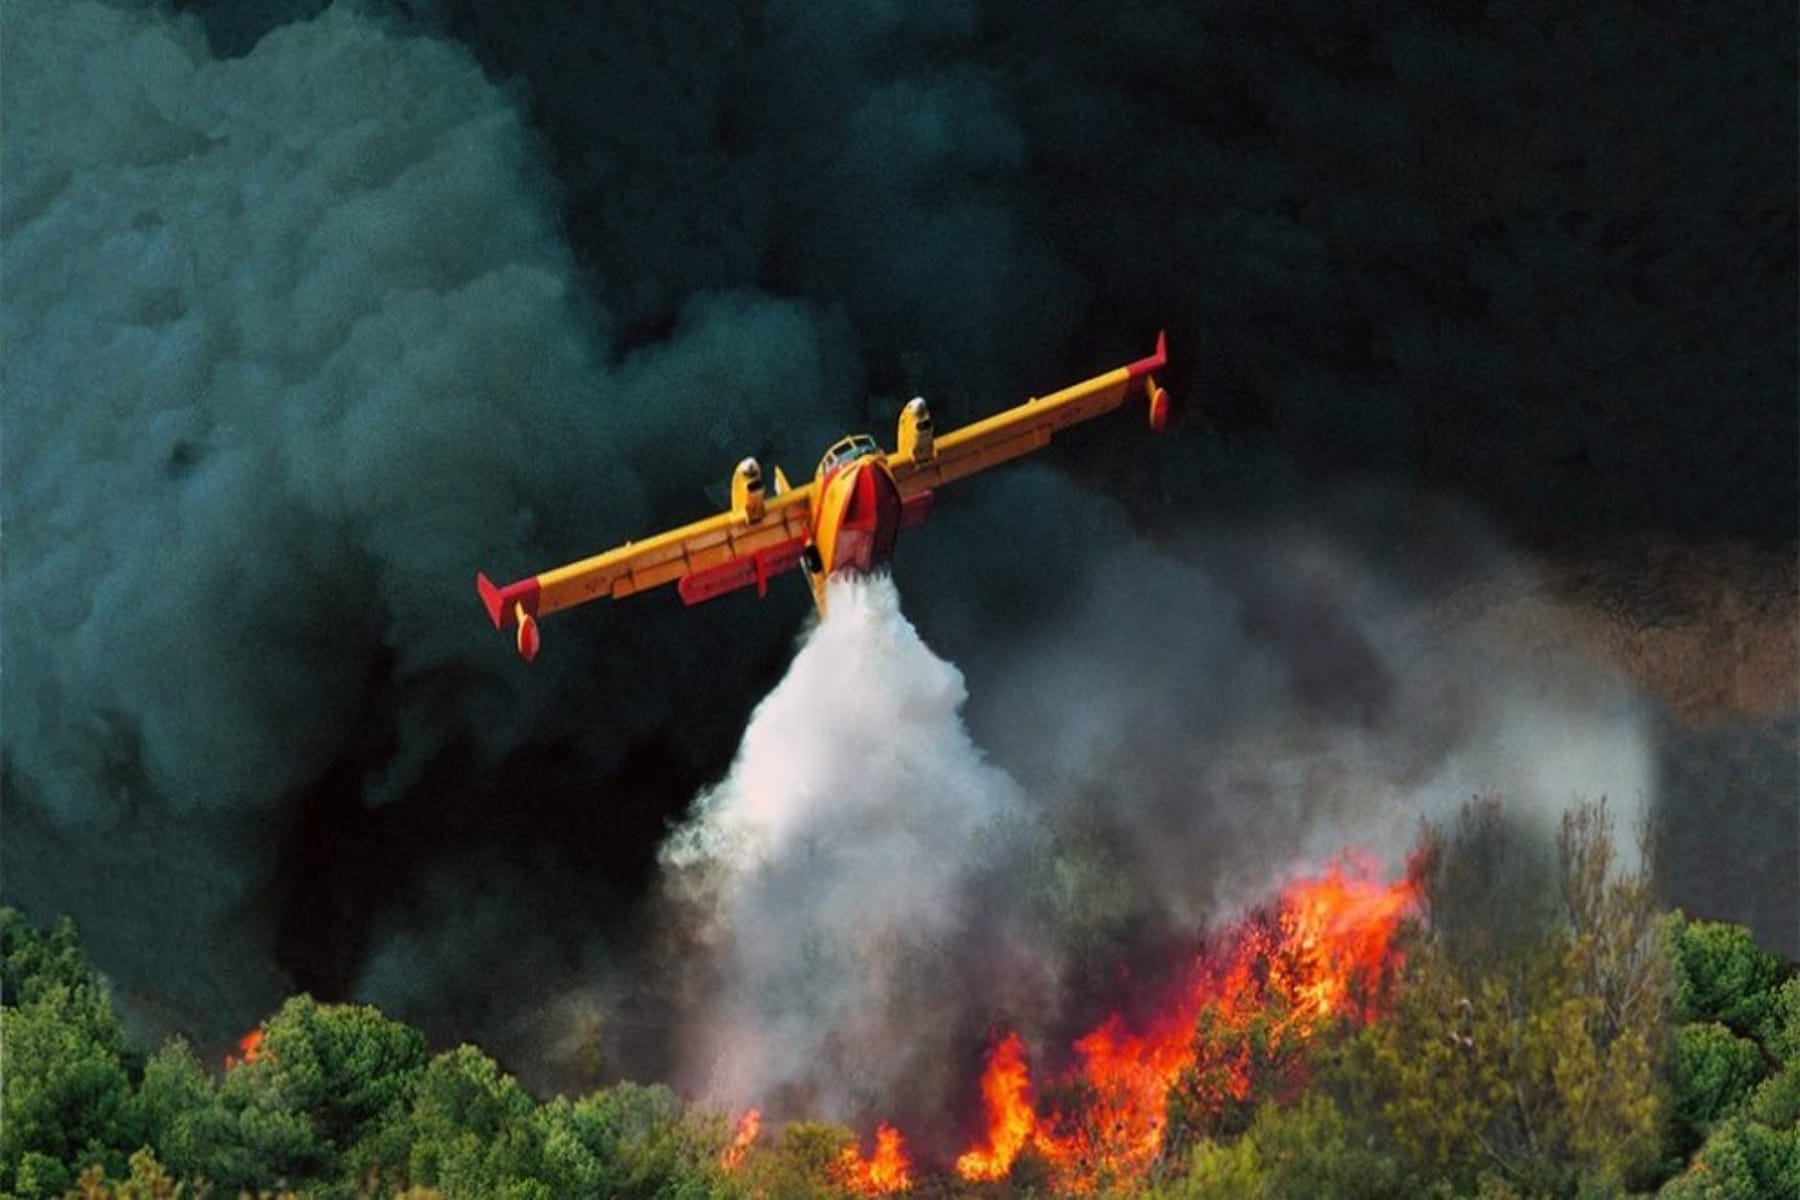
[412,0,1800,543]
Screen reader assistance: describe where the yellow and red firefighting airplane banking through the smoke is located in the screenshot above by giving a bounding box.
[475,335,1168,662]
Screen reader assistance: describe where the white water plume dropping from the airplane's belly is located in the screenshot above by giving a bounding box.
[664,578,1031,1119]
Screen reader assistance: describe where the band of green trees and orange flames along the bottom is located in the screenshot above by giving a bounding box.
[0,804,1800,1200]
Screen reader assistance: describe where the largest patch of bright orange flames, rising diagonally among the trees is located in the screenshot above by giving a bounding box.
[956,865,1417,1193]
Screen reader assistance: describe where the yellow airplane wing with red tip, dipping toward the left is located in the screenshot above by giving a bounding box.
[475,461,814,662]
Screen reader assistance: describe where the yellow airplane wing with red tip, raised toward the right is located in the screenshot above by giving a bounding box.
[887,333,1168,498]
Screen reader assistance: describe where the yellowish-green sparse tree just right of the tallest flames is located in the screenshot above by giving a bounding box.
[1332,806,1669,1193]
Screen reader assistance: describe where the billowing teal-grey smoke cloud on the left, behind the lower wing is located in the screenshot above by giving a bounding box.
[4,4,853,1024]
